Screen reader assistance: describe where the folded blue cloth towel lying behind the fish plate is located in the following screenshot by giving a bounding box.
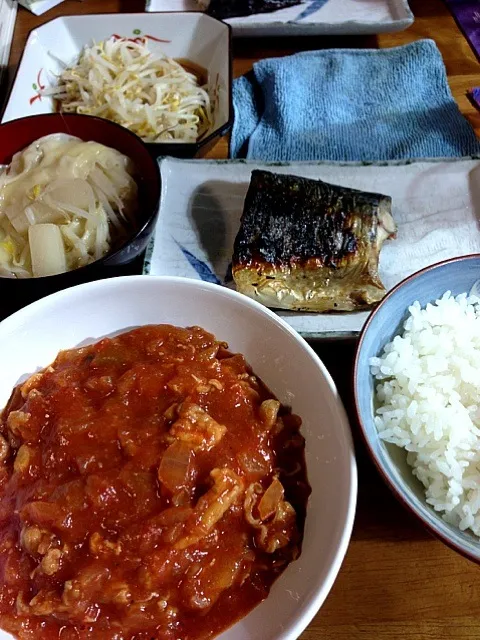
[230,40,480,161]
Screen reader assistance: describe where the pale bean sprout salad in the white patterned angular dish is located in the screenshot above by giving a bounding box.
[42,36,212,143]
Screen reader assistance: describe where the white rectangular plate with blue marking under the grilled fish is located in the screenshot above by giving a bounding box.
[144,158,480,338]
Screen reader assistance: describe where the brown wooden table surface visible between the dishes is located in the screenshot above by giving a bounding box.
[5,0,480,640]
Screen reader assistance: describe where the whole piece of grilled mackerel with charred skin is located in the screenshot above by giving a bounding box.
[232,170,396,312]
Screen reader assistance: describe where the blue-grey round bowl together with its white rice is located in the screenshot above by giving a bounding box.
[354,254,480,562]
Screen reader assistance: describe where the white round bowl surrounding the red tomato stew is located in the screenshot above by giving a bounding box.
[0,276,357,640]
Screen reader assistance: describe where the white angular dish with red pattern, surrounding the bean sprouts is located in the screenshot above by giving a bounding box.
[2,12,233,157]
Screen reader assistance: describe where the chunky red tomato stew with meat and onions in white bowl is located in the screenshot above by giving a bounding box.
[0,325,310,640]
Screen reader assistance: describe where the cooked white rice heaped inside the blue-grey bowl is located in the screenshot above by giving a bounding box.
[370,292,480,536]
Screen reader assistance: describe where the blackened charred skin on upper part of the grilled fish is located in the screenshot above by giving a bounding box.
[234,170,391,269]
